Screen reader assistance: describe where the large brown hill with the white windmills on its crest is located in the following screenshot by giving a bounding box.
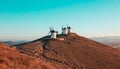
[16,33,120,69]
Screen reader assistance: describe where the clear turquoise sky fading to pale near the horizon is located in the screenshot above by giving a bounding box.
[0,0,120,41]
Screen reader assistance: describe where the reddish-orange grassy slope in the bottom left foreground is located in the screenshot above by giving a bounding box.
[0,42,55,69]
